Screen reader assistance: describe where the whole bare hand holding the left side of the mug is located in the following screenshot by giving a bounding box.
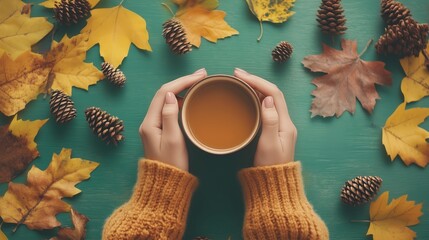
[139,68,207,171]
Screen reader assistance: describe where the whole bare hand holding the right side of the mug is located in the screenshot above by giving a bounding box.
[234,68,297,166]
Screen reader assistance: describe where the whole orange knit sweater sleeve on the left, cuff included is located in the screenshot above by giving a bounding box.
[102,159,198,240]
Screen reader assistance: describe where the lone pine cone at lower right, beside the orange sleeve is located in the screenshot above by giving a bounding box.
[341,176,383,206]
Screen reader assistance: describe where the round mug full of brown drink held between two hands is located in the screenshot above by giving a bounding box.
[182,76,259,153]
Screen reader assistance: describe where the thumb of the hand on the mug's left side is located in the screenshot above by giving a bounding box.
[161,92,181,137]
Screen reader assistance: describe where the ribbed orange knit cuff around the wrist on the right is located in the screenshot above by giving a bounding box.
[238,162,307,207]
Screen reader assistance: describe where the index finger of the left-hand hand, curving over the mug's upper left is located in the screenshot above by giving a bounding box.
[142,68,207,128]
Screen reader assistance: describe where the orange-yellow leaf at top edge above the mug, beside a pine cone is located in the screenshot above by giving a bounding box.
[173,0,238,47]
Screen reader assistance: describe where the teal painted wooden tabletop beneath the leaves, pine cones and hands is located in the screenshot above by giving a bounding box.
[0,0,429,240]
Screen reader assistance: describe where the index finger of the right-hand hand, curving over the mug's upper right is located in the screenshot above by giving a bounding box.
[234,68,292,131]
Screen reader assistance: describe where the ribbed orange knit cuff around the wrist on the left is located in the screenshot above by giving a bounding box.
[131,159,198,221]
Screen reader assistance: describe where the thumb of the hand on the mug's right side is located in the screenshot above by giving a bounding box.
[261,96,279,139]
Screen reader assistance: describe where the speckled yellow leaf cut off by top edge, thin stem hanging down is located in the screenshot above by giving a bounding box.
[246,0,295,41]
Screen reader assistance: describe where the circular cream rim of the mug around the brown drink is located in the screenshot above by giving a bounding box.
[181,74,261,155]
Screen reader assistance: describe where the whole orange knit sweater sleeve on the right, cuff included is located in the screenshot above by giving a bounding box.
[239,162,329,240]
